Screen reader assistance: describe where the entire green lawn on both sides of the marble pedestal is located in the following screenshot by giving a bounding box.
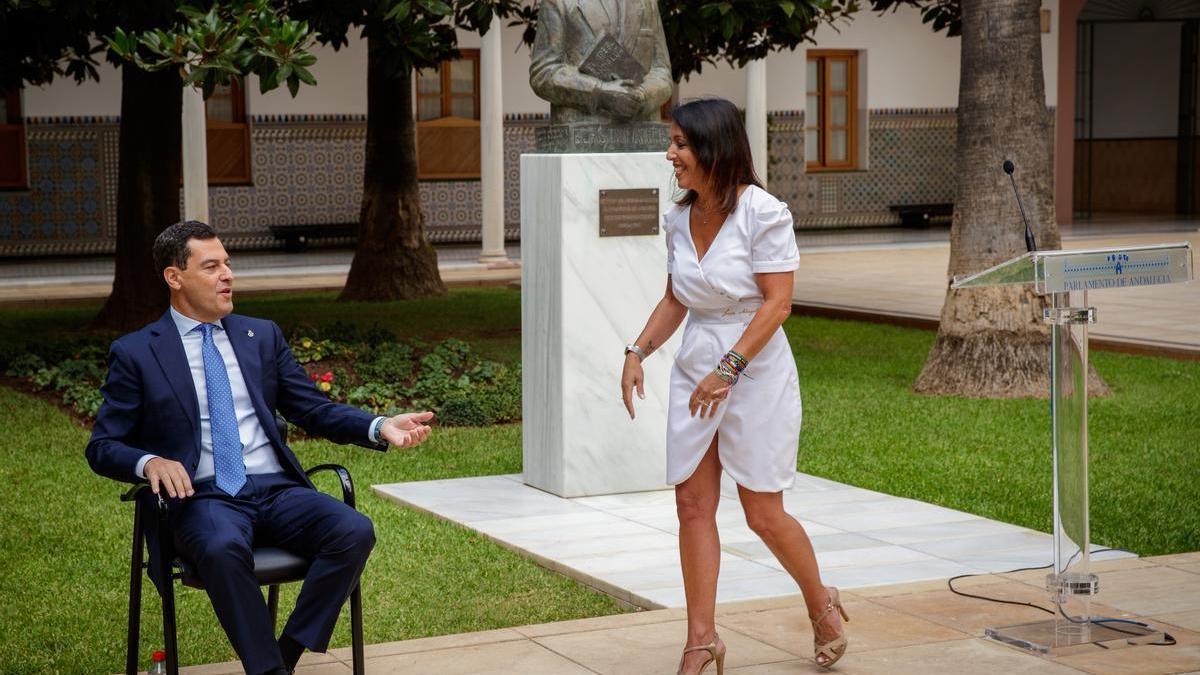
[0,288,1200,673]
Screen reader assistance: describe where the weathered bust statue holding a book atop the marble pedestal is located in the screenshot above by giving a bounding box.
[529,0,671,151]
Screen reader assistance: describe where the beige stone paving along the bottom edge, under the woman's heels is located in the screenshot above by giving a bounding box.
[171,554,1200,675]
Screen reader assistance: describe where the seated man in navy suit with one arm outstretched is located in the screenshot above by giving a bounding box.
[86,221,433,674]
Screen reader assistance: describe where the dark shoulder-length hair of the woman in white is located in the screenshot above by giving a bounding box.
[671,97,762,213]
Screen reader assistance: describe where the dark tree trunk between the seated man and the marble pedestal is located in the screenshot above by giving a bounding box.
[338,37,446,300]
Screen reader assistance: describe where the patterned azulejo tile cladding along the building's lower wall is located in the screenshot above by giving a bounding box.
[0,109,969,256]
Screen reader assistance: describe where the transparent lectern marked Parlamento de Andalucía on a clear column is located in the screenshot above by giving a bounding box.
[950,243,1192,653]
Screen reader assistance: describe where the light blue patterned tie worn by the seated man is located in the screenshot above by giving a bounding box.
[197,323,246,496]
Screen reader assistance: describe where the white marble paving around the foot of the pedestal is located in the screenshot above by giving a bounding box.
[372,473,1128,611]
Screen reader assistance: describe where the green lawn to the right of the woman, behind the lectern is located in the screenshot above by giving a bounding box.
[785,318,1200,555]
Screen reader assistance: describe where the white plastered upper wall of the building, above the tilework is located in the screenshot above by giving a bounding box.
[18,0,1060,117]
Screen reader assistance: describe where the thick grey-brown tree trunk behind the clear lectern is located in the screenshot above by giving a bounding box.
[914,0,1106,398]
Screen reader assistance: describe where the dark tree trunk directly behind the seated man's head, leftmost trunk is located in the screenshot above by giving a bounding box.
[92,65,184,330]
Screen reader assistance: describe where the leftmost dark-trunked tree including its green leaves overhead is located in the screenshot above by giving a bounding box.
[0,0,328,329]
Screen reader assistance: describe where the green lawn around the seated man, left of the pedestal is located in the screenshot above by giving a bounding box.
[0,387,620,673]
